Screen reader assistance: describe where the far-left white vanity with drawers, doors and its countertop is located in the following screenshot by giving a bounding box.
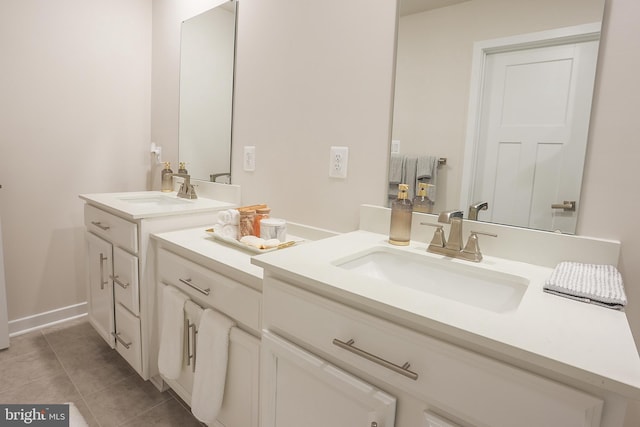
[80,189,239,379]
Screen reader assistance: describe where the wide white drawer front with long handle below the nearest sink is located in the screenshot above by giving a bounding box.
[263,277,603,427]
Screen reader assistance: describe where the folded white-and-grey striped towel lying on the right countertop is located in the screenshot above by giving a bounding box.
[544,261,627,310]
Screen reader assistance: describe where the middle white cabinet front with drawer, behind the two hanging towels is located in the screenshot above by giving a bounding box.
[157,244,262,427]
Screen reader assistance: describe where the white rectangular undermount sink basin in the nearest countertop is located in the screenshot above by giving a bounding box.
[334,247,529,313]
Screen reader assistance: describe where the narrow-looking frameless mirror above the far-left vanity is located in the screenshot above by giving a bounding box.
[179,1,237,183]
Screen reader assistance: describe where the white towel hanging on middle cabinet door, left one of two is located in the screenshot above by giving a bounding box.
[158,285,188,380]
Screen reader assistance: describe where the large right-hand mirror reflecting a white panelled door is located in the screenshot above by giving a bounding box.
[388,0,605,233]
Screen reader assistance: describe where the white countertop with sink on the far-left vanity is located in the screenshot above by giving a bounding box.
[79,191,234,220]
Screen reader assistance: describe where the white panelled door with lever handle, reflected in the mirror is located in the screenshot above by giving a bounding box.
[473,41,598,233]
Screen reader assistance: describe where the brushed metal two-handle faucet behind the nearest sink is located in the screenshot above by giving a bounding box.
[420,210,498,262]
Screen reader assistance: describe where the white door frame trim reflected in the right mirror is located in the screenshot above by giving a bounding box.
[460,22,602,212]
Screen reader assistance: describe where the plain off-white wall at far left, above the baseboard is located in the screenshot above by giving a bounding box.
[0,0,151,320]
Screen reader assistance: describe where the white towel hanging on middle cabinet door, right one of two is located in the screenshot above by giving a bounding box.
[191,308,235,424]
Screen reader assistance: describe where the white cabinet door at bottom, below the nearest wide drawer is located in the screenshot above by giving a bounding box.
[260,331,396,427]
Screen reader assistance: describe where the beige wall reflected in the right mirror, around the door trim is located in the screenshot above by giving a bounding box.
[393,0,604,211]
